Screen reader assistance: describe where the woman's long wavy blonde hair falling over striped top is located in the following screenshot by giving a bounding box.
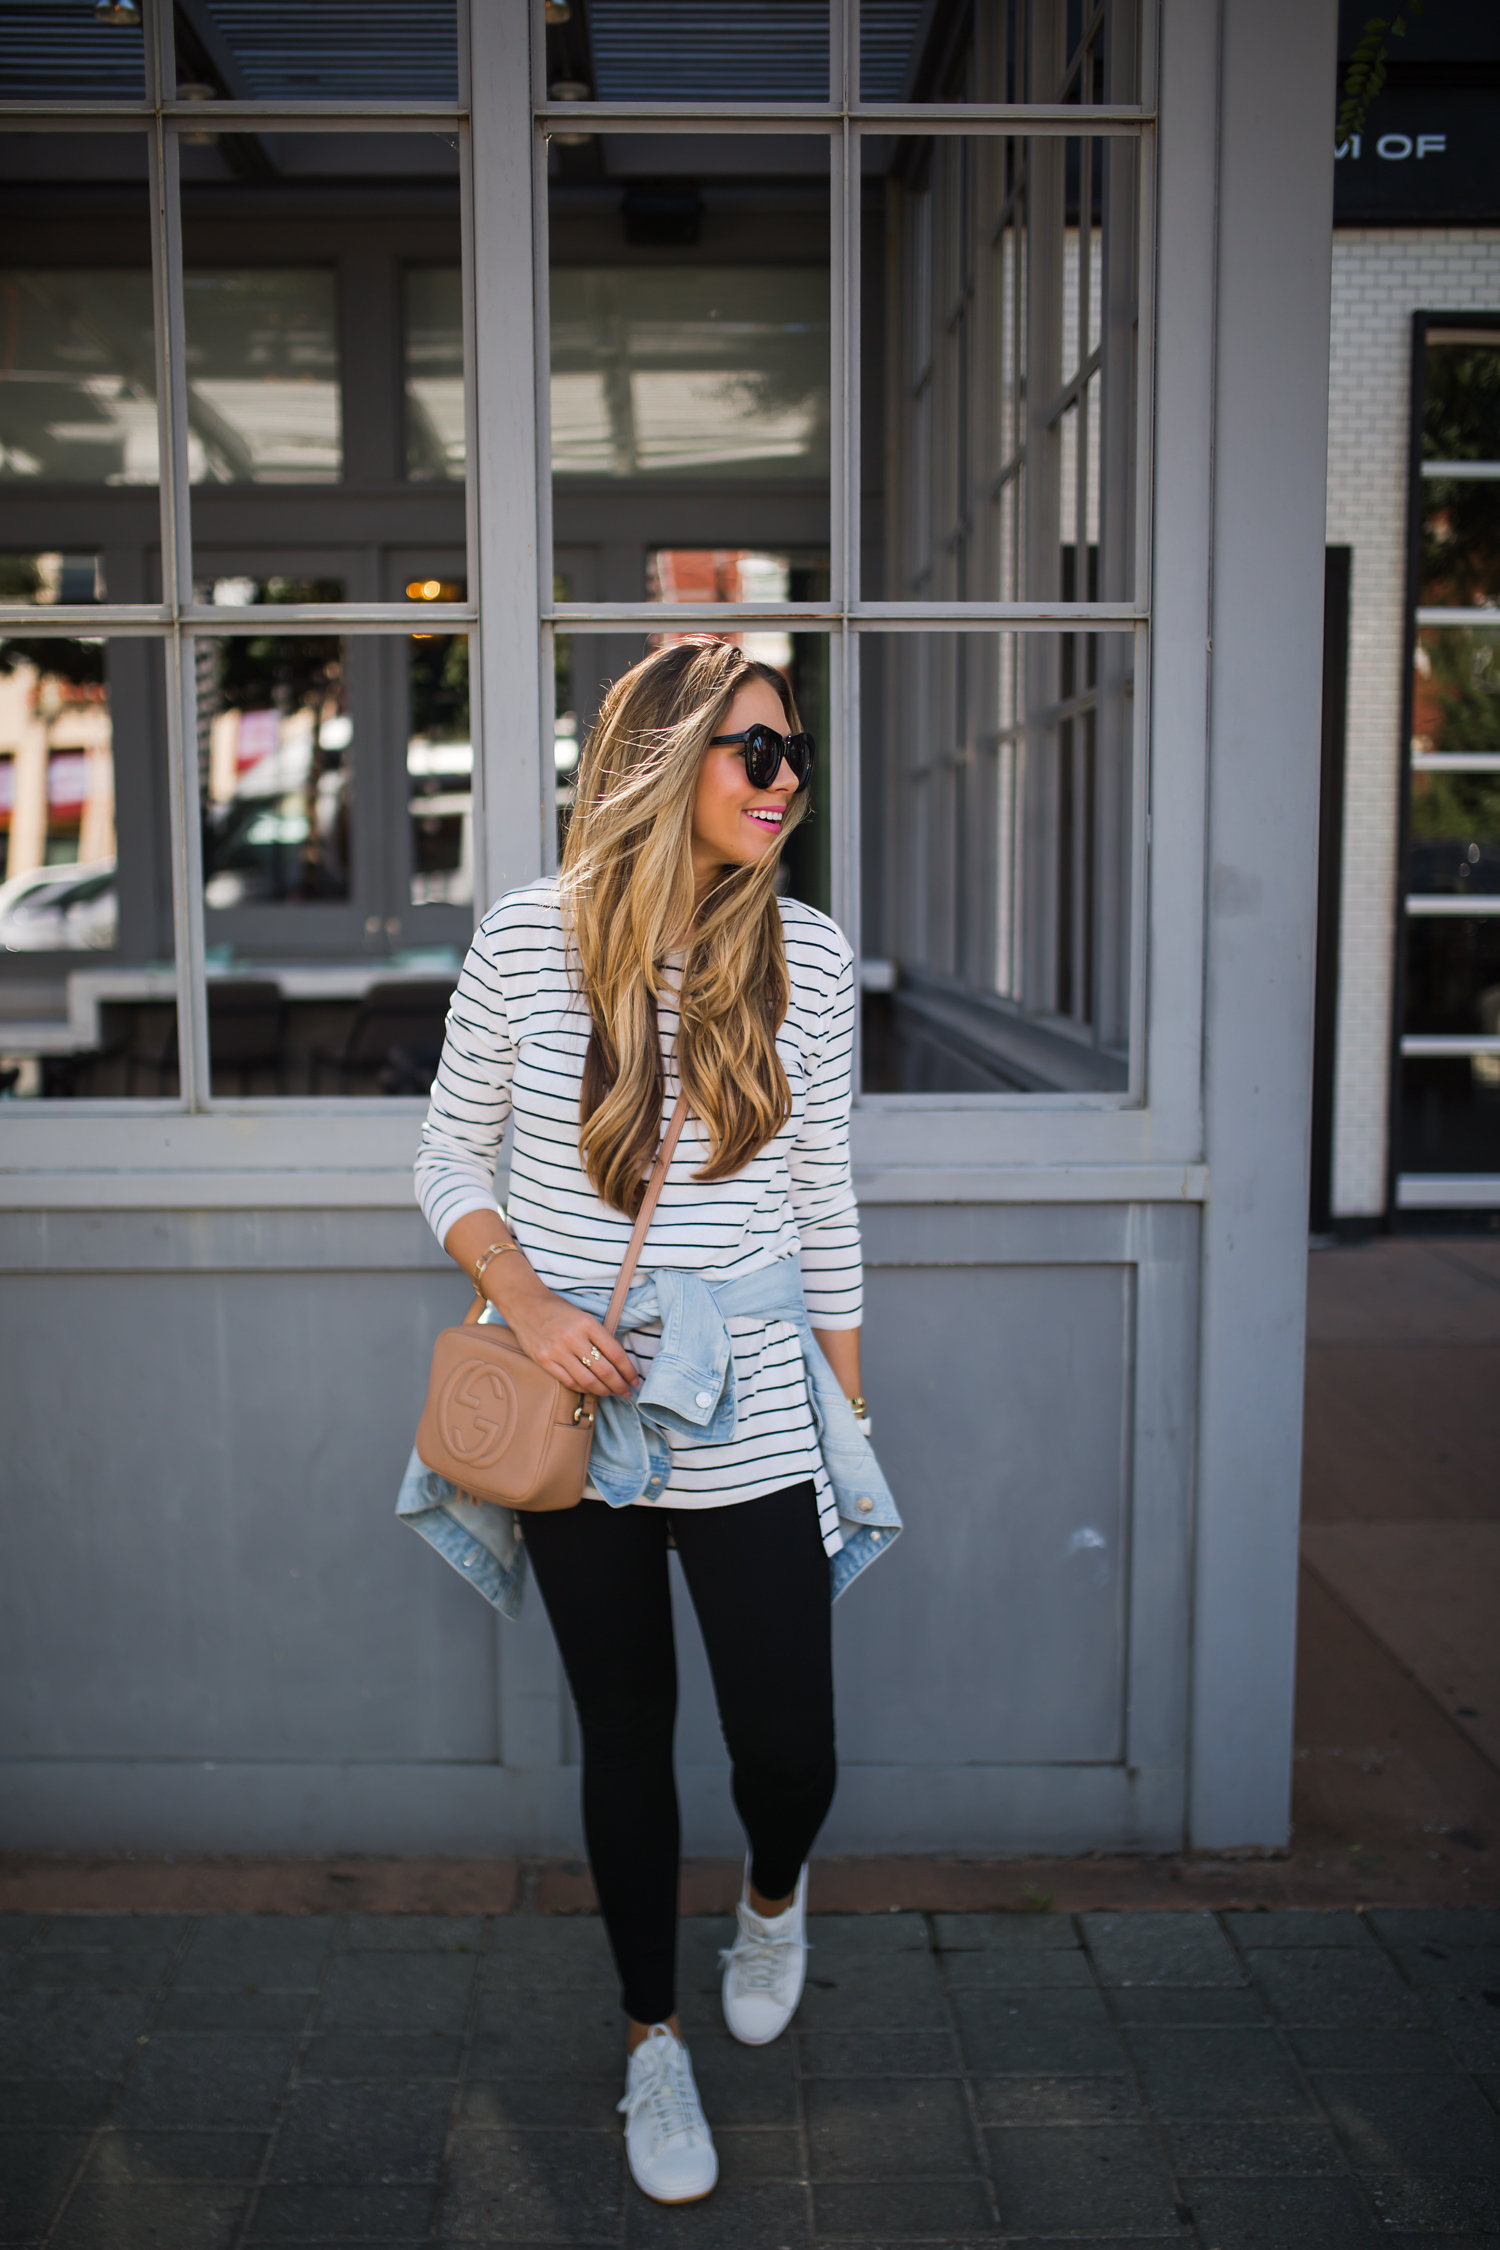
[560,639,807,1217]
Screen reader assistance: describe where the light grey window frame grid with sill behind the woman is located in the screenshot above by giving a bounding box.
[0,0,1212,1208]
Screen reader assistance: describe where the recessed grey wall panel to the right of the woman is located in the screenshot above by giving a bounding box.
[839,1265,1131,1764]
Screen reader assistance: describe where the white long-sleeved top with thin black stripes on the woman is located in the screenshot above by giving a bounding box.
[416,880,861,1553]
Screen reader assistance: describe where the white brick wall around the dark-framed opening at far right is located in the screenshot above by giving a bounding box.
[1329,227,1500,1217]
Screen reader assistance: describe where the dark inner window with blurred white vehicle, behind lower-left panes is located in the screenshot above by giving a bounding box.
[198,625,353,907]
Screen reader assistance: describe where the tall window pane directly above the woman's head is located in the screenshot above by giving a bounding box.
[549,135,830,558]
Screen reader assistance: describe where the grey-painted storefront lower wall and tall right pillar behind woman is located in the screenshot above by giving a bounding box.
[0,0,1334,1854]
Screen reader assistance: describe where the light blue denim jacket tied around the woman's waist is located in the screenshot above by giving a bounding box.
[396,1258,902,1618]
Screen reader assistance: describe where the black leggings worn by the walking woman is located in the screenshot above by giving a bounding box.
[526,1483,837,2023]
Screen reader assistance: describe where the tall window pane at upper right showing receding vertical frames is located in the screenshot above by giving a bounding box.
[861,137,1140,601]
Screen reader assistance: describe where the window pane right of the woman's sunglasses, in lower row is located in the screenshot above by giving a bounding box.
[861,632,1133,1094]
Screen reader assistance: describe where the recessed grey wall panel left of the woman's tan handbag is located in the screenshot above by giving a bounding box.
[0,1274,499,1760]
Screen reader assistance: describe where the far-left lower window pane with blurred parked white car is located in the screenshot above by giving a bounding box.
[0,634,178,1098]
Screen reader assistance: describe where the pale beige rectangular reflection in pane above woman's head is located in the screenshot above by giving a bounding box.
[551,266,830,479]
